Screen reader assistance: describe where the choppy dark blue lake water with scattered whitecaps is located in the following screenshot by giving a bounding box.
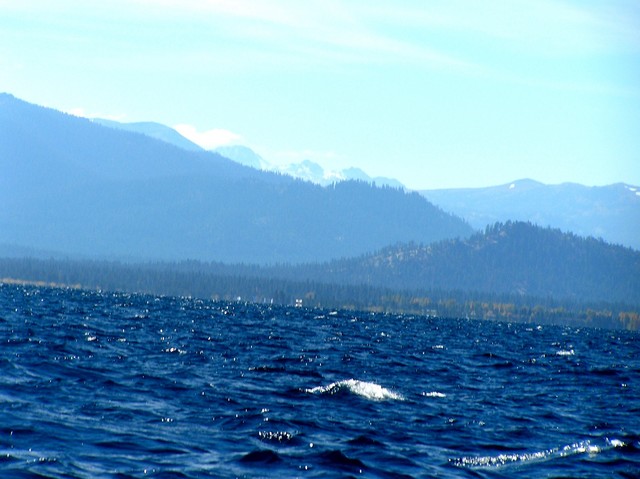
[0,286,640,478]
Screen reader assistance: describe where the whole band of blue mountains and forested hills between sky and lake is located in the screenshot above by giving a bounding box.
[0,94,640,324]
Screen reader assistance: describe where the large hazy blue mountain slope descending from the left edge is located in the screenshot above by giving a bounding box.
[0,94,471,264]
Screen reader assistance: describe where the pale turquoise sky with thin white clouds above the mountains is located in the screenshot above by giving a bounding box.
[0,0,640,189]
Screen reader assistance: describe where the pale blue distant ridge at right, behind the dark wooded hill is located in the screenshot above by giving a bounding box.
[420,179,640,250]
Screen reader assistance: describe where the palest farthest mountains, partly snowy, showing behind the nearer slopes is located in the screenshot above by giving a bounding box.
[93,110,640,249]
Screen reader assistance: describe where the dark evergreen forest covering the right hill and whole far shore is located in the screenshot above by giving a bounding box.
[0,223,640,330]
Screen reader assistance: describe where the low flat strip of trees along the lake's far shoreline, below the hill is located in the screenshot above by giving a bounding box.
[0,258,640,330]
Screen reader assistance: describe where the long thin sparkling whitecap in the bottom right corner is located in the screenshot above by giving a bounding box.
[449,439,625,469]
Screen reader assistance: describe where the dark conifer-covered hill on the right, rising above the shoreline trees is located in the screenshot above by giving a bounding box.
[267,222,640,304]
